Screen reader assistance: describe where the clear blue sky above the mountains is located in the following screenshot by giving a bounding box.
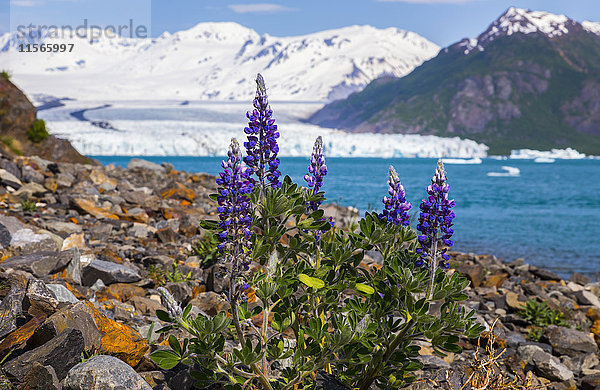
[0,0,600,46]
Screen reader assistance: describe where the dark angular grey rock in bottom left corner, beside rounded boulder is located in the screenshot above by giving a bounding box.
[2,329,85,382]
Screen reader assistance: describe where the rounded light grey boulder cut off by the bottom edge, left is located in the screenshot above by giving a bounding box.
[62,355,151,390]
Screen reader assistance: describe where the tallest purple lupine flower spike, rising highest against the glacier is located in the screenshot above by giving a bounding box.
[244,73,281,188]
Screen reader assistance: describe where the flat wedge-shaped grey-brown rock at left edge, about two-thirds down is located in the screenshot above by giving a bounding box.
[0,251,73,278]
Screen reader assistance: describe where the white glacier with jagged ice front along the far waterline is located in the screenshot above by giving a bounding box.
[39,102,488,158]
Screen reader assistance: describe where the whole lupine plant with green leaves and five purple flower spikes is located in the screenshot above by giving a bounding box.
[152,76,483,390]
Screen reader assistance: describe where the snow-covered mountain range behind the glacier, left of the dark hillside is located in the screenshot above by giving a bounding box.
[0,23,439,101]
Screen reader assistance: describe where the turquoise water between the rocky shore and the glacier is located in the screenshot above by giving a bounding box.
[94,156,600,278]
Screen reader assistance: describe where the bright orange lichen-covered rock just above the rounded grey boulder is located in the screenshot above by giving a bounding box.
[87,302,149,367]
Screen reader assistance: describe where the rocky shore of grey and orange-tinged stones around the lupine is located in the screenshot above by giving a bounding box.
[0,150,600,390]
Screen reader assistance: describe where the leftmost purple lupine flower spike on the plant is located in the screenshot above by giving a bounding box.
[217,138,254,268]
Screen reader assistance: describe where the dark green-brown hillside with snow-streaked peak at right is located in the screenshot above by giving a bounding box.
[310,8,600,155]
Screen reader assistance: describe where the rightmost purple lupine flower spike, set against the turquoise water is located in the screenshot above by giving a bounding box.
[417,160,454,271]
